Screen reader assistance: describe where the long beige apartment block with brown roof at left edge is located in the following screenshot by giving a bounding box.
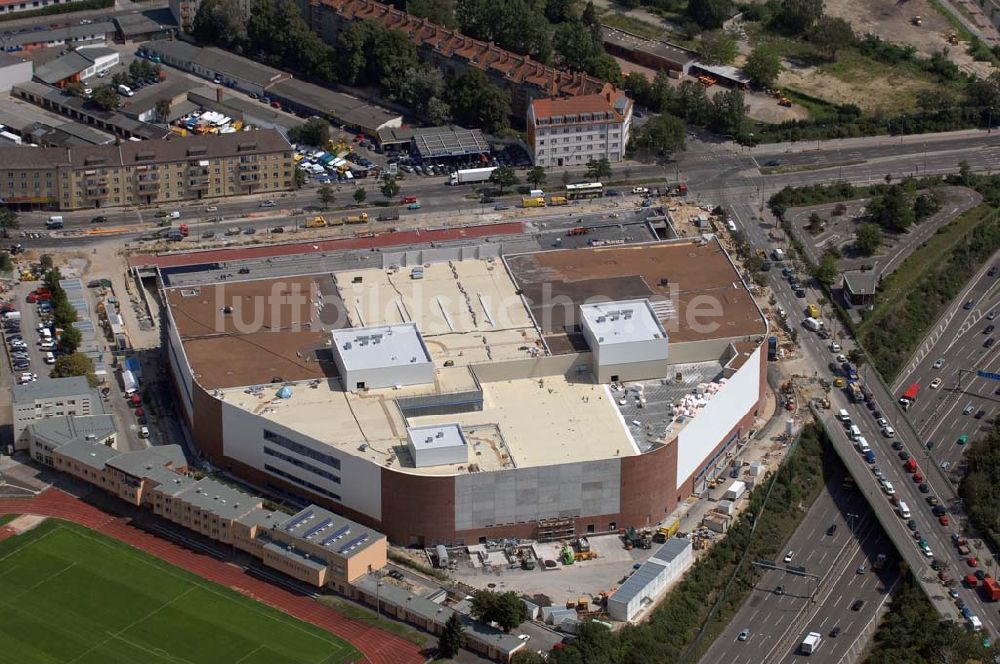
[0,129,294,210]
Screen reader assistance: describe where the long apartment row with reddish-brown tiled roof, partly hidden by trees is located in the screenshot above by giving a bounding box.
[297,0,604,120]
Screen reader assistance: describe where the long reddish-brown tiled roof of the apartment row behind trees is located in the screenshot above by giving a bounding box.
[320,0,604,97]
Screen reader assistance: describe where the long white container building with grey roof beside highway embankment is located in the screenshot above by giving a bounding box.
[608,537,694,621]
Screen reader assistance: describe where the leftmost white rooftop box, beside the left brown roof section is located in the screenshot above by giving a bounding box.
[330,323,434,392]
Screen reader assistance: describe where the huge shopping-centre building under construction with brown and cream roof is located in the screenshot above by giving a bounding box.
[143,226,767,547]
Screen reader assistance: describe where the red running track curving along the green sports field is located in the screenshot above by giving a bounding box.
[0,489,425,664]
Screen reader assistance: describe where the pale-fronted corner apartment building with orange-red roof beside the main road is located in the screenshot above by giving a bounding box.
[527,83,632,166]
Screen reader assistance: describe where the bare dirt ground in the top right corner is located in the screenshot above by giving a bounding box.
[824,0,992,76]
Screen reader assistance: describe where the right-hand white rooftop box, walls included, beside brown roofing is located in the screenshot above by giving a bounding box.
[580,299,668,383]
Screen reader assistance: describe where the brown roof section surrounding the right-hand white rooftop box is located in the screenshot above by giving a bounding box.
[507,242,767,353]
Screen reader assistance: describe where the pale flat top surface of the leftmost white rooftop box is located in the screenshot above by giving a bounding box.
[330,323,431,371]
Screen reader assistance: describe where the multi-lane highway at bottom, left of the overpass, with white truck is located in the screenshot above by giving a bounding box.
[701,474,898,664]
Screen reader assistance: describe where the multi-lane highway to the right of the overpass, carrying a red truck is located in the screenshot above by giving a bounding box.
[893,253,1000,480]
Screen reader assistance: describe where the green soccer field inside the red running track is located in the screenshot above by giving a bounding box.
[0,520,363,664]
